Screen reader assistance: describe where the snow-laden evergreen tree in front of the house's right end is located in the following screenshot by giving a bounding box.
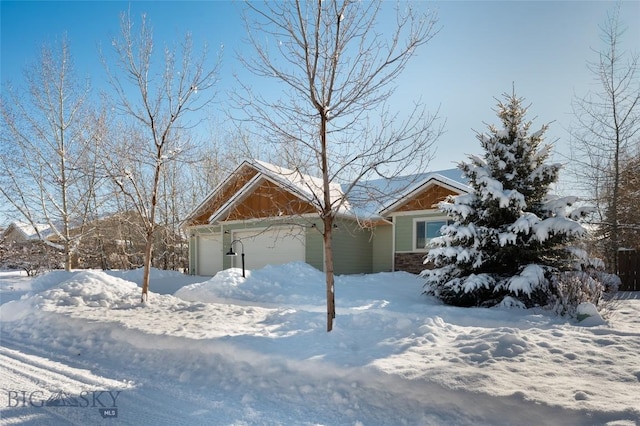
[422,94,588,307]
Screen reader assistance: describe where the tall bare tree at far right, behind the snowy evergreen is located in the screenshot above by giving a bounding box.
[571,4,640,269]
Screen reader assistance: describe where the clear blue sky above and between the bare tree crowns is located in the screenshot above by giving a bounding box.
[0,1,640,176]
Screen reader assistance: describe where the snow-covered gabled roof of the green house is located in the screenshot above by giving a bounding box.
[181,160,471,227]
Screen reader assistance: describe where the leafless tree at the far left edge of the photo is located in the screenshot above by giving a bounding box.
[0,37,100,270]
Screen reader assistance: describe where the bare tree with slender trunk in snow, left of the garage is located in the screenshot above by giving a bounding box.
[103,13,220,302]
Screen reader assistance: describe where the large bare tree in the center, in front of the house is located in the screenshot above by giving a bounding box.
[236,0,441,331]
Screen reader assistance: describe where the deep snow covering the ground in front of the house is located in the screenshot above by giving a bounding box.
[0,263,640,425]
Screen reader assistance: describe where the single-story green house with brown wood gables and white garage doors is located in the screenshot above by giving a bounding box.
[182,161,471,275]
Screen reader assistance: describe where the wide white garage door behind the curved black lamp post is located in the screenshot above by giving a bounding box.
[232,226,305,270]
